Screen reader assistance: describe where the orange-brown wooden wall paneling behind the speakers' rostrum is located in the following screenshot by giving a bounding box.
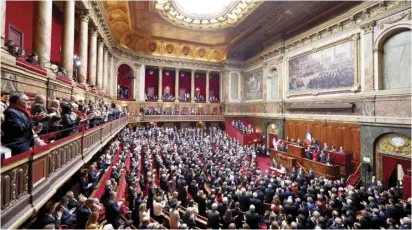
[285,120,361,163]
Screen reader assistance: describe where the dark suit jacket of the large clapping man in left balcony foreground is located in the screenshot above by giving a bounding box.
[1,107,38,156]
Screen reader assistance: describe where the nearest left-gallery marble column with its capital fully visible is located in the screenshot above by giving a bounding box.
[77,10,89,84]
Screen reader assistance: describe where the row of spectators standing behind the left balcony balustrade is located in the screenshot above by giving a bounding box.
[1,92,125,156]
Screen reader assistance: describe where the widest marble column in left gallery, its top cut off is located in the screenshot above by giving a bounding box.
[33,0,53,65]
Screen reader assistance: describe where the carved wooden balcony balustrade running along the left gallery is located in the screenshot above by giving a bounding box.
[0,117,129,229]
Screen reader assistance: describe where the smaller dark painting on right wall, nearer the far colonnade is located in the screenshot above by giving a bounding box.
[243,68,263,101]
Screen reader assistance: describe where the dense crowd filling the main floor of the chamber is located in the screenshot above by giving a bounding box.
[88,127,411,229]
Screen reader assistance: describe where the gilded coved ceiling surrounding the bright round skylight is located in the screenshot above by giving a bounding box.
[99,0,360,62]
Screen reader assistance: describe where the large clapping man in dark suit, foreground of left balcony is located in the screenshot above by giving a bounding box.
[1,92,46,156]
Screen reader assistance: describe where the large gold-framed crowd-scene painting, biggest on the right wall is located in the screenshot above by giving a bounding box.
[286,34,359,97]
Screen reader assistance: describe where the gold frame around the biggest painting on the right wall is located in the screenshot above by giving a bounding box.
[286,33,360,98]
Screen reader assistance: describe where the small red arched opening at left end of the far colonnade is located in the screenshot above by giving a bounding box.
[117,64,133,99]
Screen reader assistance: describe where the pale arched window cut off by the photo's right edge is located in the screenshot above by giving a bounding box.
[381,30,411,90]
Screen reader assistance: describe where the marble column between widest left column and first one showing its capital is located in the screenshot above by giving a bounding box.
[62,0,75,79]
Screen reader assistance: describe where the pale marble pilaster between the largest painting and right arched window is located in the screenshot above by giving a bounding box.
[361,21,375,91]
